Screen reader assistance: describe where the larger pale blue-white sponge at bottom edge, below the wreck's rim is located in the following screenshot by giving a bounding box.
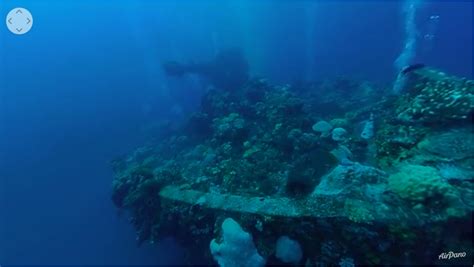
[210,218,265,267]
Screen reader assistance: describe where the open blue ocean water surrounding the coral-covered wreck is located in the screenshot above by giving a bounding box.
[0,0,474,264]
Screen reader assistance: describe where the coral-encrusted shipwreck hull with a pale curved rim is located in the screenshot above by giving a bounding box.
[113,67,474,265]
